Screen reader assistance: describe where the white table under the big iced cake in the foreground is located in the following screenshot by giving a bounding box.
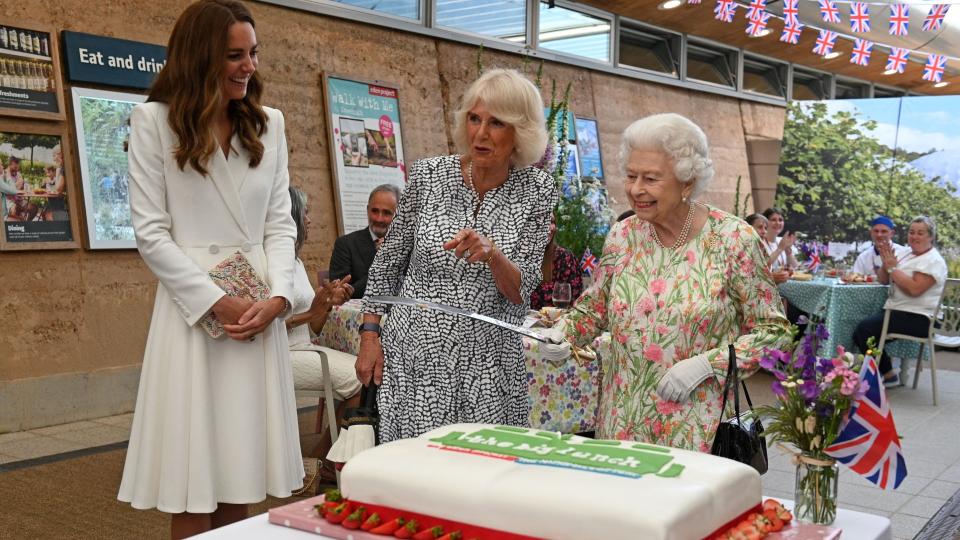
[194,497,893,540]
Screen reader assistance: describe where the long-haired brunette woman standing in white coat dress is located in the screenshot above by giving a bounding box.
[119,0,303,538]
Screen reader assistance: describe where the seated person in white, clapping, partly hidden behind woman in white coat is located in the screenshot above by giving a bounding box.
[286,187,360,468]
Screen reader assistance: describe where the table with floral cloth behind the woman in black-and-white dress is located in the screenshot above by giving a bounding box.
[314,300,600,433]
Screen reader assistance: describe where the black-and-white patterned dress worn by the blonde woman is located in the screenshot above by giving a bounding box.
[363,156,557,442]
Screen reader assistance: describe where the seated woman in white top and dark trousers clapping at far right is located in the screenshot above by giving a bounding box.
[853,216,947,386]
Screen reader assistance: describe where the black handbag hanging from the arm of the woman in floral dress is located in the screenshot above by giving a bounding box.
[710,345,767,474]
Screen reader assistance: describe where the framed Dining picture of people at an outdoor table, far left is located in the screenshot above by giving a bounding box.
[0,123,78,250]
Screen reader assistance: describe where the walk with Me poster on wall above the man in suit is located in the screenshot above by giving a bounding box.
[323,74,406,234]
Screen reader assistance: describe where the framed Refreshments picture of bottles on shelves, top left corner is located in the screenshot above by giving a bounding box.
[0,19,65,120]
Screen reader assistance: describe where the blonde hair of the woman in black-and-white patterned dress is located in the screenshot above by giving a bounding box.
[453,69,547,168]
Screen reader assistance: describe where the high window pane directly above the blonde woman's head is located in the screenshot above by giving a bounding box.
[437,0,527,43]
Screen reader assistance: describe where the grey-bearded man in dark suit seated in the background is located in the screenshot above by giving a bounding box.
[330,184,400,298]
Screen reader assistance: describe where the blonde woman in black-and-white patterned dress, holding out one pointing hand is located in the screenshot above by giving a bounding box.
[357,70,557,442]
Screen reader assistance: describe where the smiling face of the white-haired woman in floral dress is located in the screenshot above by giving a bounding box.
[624,150,693,229]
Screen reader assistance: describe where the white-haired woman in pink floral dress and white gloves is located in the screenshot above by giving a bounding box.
[549,114,790,452]
